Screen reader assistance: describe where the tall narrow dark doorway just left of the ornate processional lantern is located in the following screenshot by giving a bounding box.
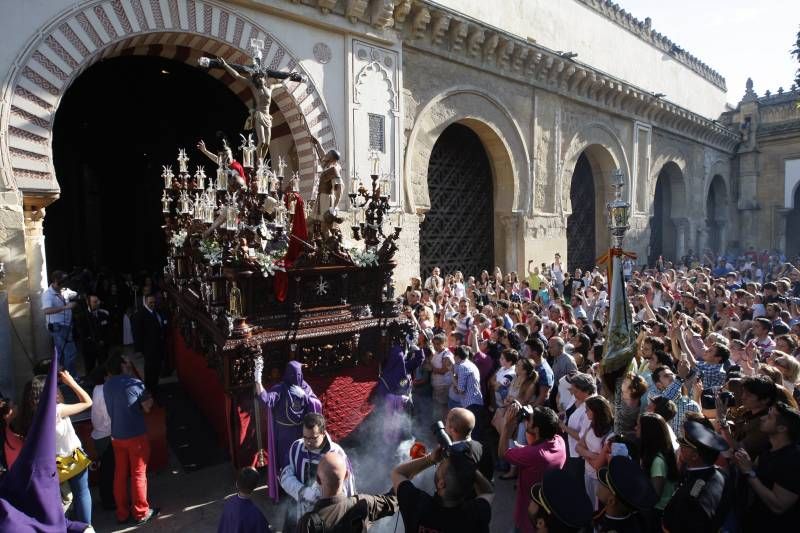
[567,153,597,272]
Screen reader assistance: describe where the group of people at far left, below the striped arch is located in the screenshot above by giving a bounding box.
[0,269,167,524]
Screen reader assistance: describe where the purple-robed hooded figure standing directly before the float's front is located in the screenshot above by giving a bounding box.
[259,361,322,502]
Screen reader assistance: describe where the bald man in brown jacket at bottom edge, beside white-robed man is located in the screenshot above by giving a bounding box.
[297,453,397,533]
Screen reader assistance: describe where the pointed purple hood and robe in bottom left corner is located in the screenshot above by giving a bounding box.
[0,361,87,533]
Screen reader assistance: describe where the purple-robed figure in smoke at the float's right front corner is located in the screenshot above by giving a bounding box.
[377,343,425,443]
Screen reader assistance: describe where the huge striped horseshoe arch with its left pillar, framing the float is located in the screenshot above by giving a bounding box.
[0,0,337,382]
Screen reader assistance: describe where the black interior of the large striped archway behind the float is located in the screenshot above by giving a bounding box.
[44,56,247,272]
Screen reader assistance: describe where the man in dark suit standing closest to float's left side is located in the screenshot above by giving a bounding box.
[133,294,167,396]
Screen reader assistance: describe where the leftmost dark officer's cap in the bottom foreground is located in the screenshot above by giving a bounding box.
[531,469,592,529]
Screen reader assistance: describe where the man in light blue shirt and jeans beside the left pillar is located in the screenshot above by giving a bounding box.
[42,270,78,375]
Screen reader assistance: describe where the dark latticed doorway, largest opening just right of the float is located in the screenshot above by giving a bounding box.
[419,124,494,277]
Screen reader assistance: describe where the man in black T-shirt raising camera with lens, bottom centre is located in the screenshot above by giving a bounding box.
[392,420,494,533]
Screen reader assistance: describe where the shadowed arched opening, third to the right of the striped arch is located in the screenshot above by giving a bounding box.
[648,161,686,265]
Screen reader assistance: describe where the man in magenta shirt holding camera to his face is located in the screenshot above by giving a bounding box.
[497,402,567,533]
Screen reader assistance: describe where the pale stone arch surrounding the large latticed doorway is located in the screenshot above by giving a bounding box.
[406,87,532,275]
